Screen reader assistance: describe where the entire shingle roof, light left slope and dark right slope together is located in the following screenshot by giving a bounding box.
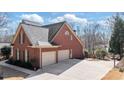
[21,20,65,45]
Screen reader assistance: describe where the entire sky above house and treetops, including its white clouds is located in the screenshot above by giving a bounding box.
[0,12,115,34]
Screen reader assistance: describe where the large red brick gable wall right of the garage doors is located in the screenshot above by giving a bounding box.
[52,24,83,58]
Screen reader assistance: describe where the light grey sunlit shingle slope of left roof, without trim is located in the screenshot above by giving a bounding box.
[21,24,49,45]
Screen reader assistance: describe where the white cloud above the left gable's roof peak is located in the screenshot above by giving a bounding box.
[21,14,44,24]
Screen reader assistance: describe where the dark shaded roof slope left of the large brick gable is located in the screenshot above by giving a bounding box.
[42,21,65,41]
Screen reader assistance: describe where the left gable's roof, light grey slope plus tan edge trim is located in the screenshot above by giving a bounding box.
[12,22,49,45]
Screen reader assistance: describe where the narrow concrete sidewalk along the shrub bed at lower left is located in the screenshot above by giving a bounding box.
[0,60,35,75]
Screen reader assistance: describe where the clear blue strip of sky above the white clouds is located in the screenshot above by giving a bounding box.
[9,12,115,21]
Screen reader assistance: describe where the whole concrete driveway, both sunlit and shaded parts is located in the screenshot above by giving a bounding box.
[28,59,116,80]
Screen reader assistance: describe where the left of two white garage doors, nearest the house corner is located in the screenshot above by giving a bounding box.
[42,51,56,66]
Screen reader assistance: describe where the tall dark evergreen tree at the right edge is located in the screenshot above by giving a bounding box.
[109,14,124,58]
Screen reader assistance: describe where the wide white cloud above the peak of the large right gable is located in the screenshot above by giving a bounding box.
[50,14,88,24]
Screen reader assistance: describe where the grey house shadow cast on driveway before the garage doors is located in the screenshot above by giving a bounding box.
[30,59,81,77]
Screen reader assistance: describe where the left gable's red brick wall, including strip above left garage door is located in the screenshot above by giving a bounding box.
[13,25,58,67]
